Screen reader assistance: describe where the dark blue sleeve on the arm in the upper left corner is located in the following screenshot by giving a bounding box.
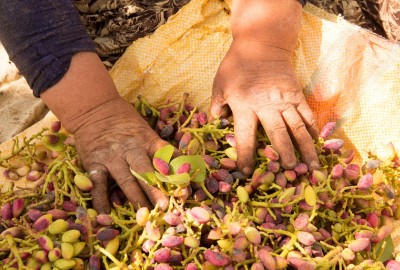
[0,0,95,97]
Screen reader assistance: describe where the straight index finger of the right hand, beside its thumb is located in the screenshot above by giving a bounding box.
[232,106,258,175]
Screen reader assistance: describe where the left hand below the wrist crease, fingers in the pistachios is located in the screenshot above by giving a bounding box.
[74,98,168,212]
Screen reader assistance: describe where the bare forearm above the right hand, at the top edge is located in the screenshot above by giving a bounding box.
[231,0,302,53]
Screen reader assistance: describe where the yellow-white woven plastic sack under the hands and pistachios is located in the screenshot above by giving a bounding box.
[0,0,400,250]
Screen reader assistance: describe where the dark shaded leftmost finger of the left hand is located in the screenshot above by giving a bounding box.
[88,164,111,214]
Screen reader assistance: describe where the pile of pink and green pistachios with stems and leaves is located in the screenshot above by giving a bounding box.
[0,94,400,270]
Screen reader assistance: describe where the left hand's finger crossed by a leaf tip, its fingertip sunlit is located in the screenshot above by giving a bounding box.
[126,152,169,209]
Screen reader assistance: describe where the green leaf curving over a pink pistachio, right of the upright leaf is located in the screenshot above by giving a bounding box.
[170,155,206,183]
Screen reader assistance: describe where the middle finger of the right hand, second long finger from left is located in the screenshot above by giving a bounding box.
[258,110,297,169]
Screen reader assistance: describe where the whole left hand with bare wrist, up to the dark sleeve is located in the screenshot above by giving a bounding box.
[40,52,168,213]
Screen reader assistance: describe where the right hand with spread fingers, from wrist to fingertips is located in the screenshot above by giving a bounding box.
[211,39,319,174]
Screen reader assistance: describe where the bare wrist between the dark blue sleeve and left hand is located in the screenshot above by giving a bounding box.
[40,52,126,133]
